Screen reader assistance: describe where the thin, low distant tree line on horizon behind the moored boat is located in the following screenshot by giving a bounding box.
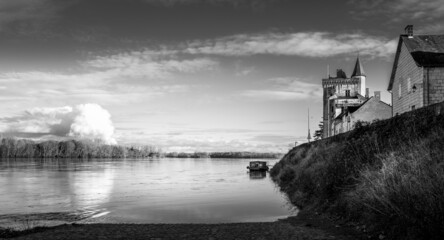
[164,152,282,158]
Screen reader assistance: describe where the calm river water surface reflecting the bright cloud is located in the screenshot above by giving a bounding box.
[0,158,295,224]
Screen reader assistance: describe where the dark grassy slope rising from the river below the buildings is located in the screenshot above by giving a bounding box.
[271,106,444,239]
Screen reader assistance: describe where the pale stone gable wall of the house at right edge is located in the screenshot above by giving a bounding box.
[392,43,424,115]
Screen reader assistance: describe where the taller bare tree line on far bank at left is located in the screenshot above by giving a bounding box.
[0,138,161,158]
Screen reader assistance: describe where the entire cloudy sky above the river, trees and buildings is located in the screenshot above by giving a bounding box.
[0,0,444,152]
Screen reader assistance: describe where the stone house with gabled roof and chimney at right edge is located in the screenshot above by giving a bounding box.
[387,25,444,115]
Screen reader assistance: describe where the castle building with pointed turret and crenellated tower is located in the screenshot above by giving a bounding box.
[322,57,392,138]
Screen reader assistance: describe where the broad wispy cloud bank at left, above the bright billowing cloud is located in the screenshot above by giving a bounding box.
[0,51,218,103]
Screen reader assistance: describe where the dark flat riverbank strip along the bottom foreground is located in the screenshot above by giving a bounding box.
[0,211,377,240]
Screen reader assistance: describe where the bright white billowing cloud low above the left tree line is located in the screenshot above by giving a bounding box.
[0,104,117,144]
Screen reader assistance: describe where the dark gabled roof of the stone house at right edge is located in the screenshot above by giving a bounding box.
[387,35,444,91]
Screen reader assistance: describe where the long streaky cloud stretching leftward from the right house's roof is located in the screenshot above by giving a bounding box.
[184,32,397,58]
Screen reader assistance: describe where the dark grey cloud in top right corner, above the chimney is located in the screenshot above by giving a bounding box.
[349,0,444,22]
